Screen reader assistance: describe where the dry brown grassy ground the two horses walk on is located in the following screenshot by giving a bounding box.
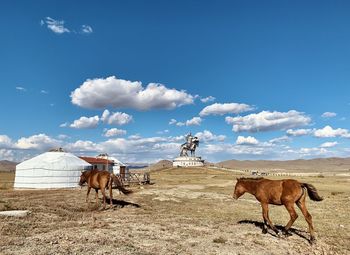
[0,168,350,255]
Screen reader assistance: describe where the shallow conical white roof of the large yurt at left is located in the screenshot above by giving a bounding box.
[16,152,91,170]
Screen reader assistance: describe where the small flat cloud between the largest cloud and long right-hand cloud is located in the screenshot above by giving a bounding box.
[199,103,254,116]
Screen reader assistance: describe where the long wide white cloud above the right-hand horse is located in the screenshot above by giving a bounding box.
[225,110,311,133]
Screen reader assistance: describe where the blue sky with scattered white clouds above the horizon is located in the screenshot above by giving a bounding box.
[0,0,350,163]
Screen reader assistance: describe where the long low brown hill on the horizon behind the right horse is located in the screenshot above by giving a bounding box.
[215,158,350,172]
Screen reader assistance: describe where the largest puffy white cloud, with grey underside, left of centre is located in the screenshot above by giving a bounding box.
[71,76,194,110]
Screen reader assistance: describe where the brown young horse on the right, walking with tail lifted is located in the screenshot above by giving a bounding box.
[233,178,323,243]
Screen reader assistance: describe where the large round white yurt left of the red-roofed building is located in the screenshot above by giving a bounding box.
[14,151,91,189]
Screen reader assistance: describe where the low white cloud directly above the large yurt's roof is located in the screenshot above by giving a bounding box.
[15,134,62,150]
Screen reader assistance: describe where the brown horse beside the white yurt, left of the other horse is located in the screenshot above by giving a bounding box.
[79,169,132,209]
